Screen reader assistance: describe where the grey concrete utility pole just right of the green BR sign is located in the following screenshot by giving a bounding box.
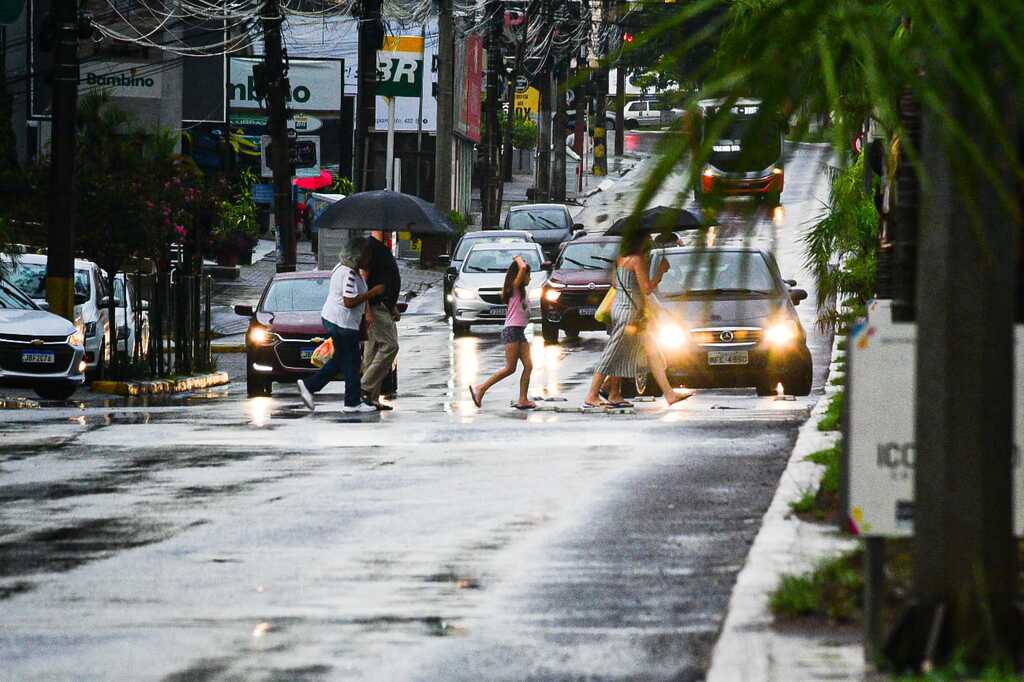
[432,0,455,213]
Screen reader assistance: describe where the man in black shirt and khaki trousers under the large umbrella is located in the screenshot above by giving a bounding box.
[361,229,401,410]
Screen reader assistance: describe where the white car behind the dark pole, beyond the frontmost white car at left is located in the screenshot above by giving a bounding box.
[6,254,111,374]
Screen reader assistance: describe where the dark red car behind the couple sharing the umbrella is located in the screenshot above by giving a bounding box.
[234,270,406,396]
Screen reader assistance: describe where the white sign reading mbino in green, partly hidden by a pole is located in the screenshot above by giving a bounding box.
[227,57,343,112]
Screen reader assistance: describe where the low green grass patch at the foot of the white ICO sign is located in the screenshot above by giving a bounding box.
[769,551,864,623]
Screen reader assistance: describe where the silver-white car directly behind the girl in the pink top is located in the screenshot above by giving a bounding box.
[452,244,550,334]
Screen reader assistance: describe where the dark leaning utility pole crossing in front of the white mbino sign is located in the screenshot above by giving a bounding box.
[261,0,296,272]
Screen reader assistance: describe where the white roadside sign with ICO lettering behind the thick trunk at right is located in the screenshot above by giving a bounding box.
[846,301,1024,538]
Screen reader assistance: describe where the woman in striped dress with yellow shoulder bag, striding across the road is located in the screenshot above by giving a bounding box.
[582,231,683,410]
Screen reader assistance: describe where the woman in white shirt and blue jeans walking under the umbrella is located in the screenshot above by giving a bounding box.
[298,238,384,412]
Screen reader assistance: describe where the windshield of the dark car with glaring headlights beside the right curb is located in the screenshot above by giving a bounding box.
[651,251,776,296]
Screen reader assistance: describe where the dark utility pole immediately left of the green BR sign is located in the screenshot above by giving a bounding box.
[352,0,382,191]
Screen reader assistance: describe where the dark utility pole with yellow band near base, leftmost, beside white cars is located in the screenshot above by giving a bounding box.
[46,0,79,322]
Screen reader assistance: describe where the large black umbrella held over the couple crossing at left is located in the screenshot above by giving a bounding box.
[318,189,457,237]
